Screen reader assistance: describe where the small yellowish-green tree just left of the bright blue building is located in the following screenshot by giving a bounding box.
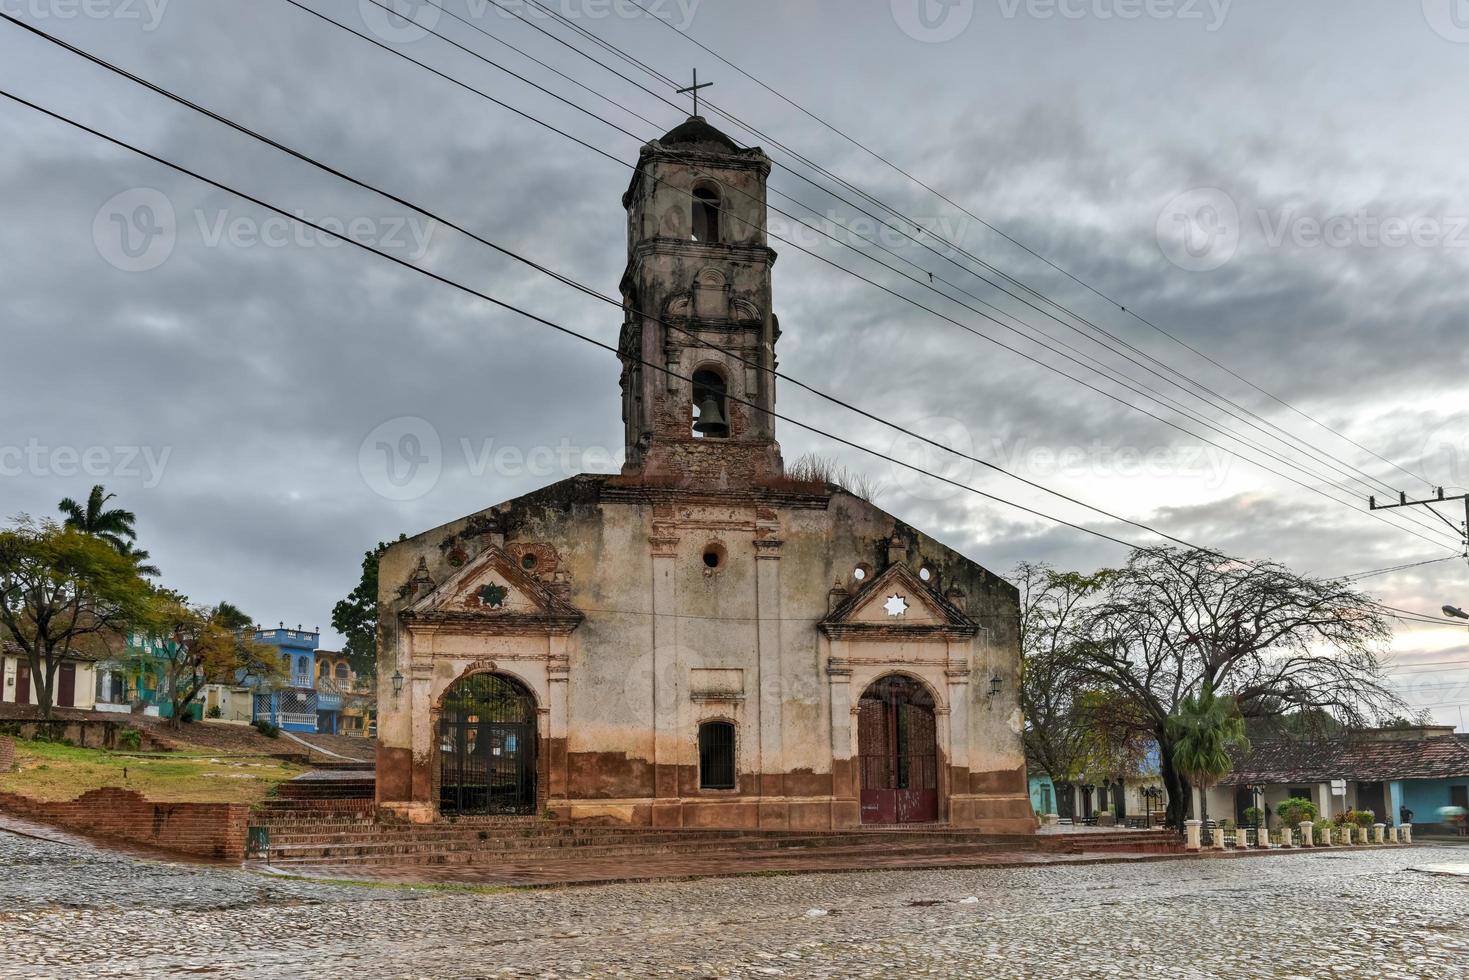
[153,592,282,727]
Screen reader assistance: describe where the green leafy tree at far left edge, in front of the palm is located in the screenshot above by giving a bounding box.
[0,517,154,718]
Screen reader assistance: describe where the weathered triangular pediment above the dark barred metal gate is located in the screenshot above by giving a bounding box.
[404,547,582,633]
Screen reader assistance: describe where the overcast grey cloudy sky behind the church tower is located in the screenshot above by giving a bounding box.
[0,0,1469,723]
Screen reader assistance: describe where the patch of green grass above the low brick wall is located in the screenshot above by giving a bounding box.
[0,741,306,804]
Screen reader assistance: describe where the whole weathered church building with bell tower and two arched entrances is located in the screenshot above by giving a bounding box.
[378,116,1036,833]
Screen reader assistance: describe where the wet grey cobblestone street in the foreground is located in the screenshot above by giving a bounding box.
[0,832,1469,980]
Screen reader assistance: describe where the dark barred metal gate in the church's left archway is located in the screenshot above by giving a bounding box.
[439,674,536,814]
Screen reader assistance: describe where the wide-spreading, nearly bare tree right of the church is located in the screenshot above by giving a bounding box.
[1028,548,1403,826]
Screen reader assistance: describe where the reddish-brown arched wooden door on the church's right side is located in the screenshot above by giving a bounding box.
[856,676,939,824]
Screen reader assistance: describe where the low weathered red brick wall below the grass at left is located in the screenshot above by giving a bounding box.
[0,786,250,861]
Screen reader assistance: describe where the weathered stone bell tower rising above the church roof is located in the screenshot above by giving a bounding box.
[618,116,783,488]
